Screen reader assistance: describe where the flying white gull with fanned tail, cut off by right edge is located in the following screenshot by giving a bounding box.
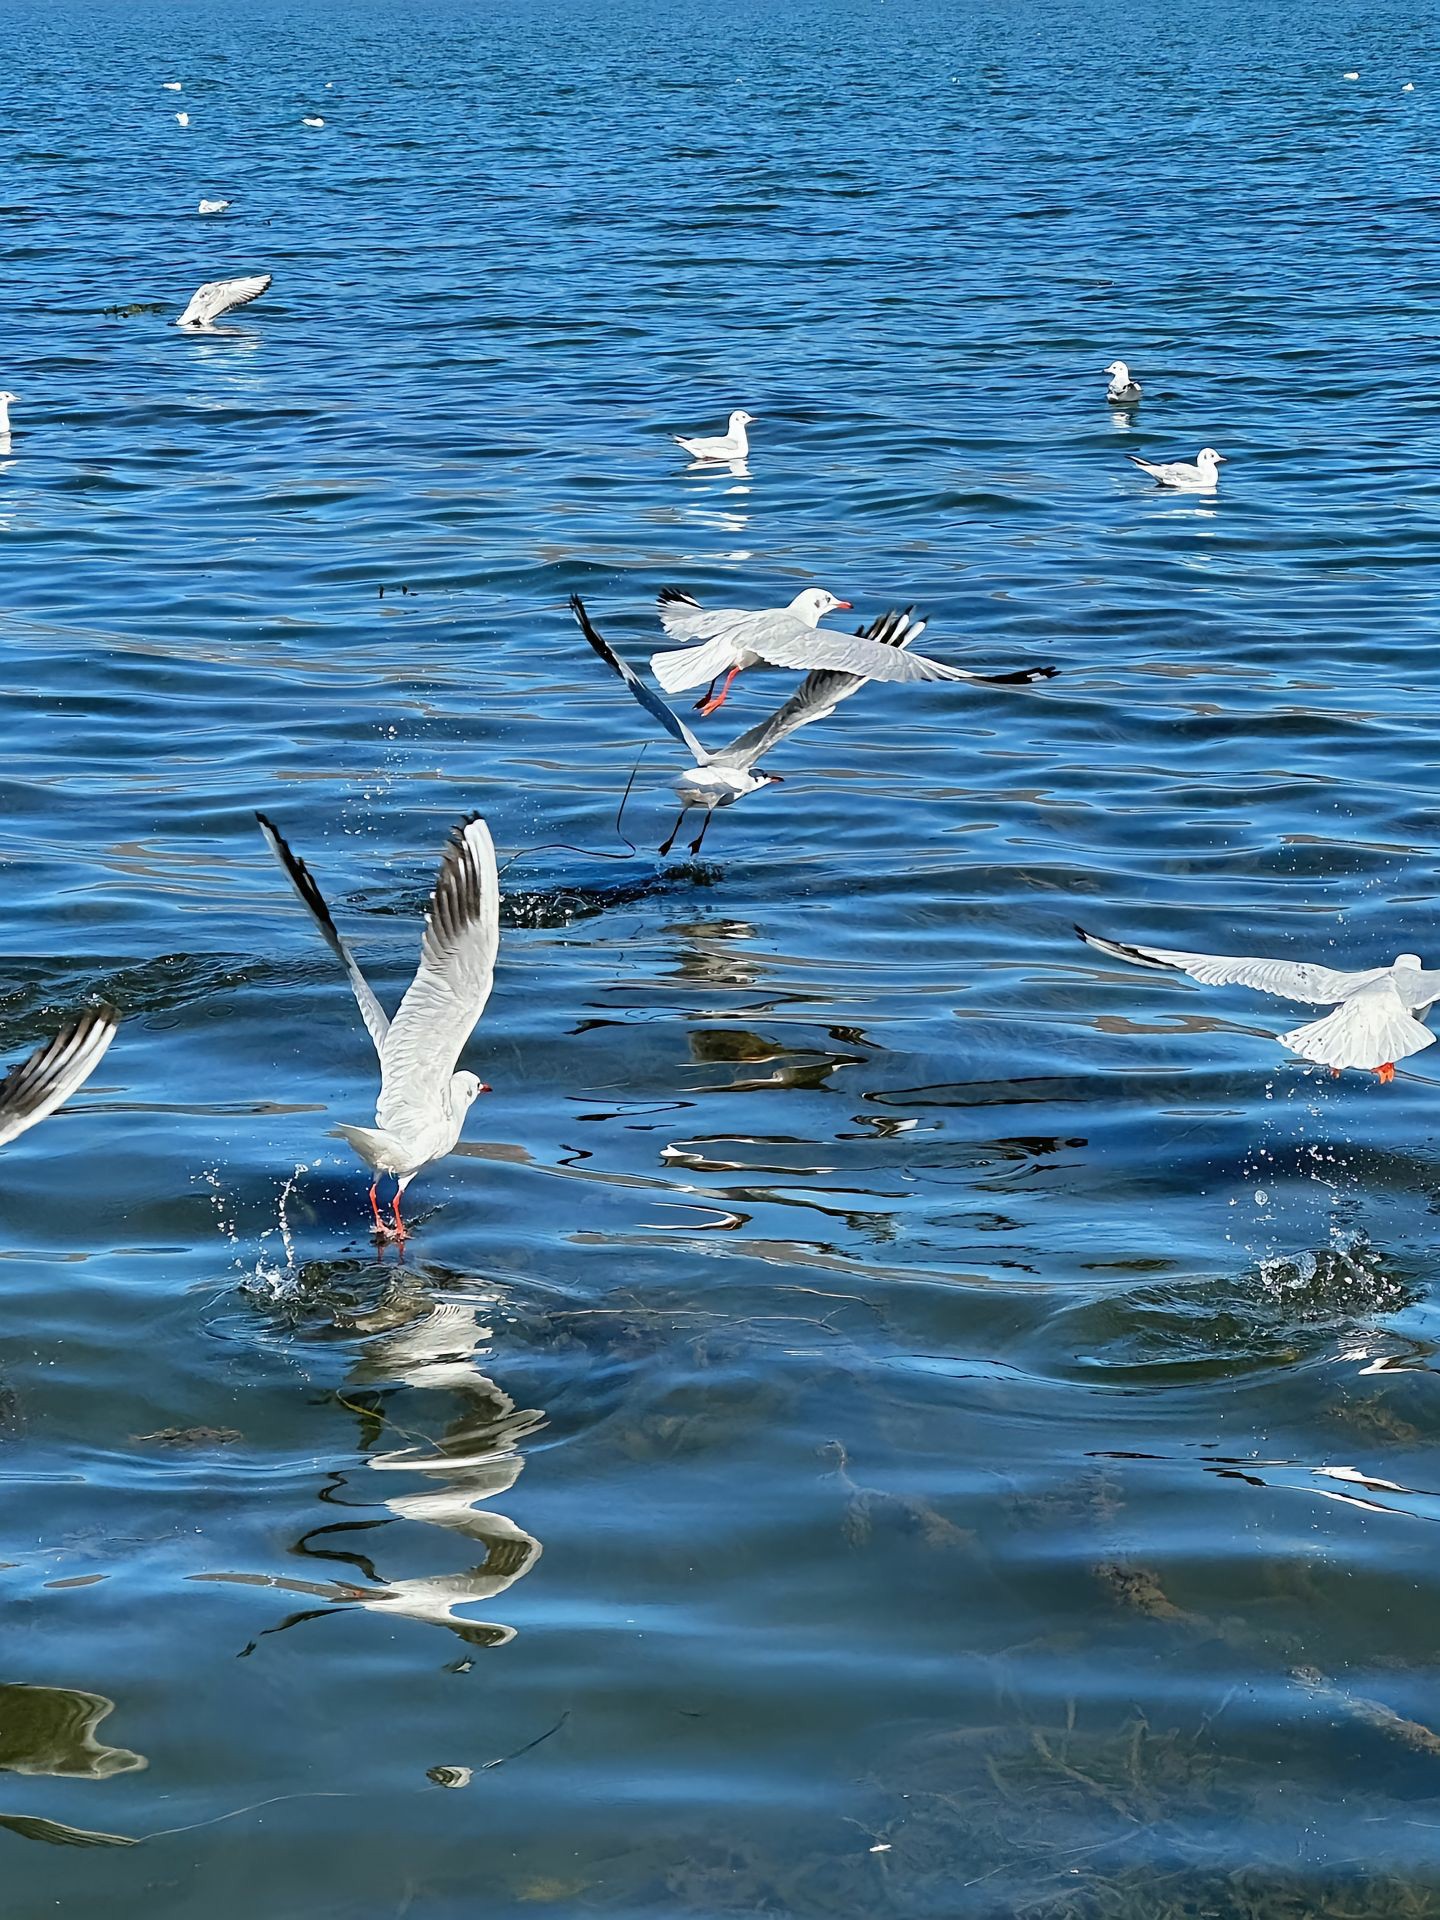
[1075,927,1440,1085]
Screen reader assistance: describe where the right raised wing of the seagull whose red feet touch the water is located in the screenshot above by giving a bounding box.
[374,814,499,1131]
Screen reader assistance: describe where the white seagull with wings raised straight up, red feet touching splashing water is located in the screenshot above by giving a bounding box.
[255,814,499,1240]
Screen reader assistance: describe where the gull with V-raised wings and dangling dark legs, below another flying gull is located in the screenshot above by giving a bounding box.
[570,593,925,854]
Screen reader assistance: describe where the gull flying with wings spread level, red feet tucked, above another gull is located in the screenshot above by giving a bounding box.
[651,588,1054,714]
